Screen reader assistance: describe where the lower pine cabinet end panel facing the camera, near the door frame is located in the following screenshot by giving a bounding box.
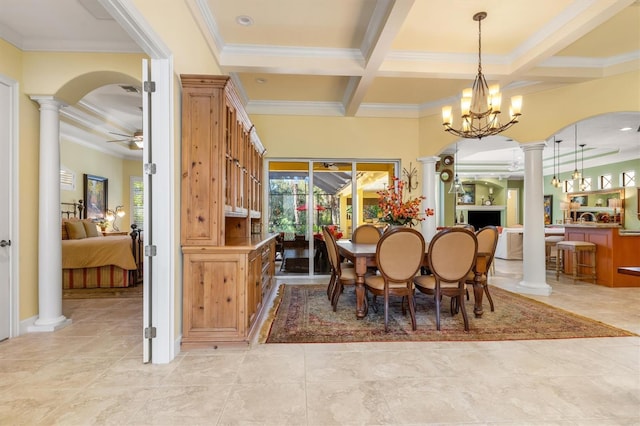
[183,254,246,342]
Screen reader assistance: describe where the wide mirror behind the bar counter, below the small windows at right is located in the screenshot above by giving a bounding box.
[567,188,624,224]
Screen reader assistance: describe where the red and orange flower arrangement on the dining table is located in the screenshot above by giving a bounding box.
[378,177,434,226]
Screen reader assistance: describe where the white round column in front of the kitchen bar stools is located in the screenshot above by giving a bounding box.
[514,143,552,296]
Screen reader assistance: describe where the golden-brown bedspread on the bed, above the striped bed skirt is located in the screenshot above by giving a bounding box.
[62,235,136,270]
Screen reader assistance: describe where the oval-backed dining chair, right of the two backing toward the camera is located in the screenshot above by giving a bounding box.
[413,228,478,331]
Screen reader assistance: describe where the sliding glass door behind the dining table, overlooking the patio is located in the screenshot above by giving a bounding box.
[267,159,399,275]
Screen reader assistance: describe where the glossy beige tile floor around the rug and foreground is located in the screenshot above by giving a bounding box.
[0,260,640,425]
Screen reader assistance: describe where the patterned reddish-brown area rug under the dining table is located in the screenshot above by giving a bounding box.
[263,284,635,343]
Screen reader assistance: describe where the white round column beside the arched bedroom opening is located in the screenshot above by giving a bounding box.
[27,96,71,332]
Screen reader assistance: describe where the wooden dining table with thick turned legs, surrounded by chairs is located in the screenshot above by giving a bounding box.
[336,240,491,319]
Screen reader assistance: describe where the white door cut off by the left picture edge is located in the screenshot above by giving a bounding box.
[0,78,13,340]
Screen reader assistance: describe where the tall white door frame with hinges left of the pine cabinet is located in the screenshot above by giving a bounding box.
[99,0,180,364]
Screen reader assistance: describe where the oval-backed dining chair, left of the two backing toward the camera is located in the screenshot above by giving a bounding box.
[364,227,425,332]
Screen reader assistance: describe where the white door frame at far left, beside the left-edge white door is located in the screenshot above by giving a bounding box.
[0,74,20,338]
